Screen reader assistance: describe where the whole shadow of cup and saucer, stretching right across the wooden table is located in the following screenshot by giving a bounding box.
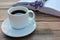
[3,29,54,40]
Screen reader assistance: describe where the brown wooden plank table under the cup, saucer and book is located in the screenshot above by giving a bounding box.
[0,1,60,40]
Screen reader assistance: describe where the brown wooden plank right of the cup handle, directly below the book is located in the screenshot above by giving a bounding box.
[35,11,60,22]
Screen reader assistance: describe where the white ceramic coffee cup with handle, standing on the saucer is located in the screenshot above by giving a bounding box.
[8,6,35,29]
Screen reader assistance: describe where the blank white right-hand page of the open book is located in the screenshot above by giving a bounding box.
[44,0,60,11]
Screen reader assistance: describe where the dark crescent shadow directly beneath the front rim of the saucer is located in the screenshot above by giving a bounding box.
[3,31,35,40]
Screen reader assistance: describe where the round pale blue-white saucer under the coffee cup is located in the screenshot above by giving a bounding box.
[1,18,36,37]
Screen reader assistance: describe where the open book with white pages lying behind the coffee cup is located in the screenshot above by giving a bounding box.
[13,0,60,16]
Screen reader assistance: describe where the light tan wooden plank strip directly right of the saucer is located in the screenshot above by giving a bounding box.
[37,22,60,31]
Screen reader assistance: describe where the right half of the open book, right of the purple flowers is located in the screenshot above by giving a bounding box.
[39,0,60,17]
